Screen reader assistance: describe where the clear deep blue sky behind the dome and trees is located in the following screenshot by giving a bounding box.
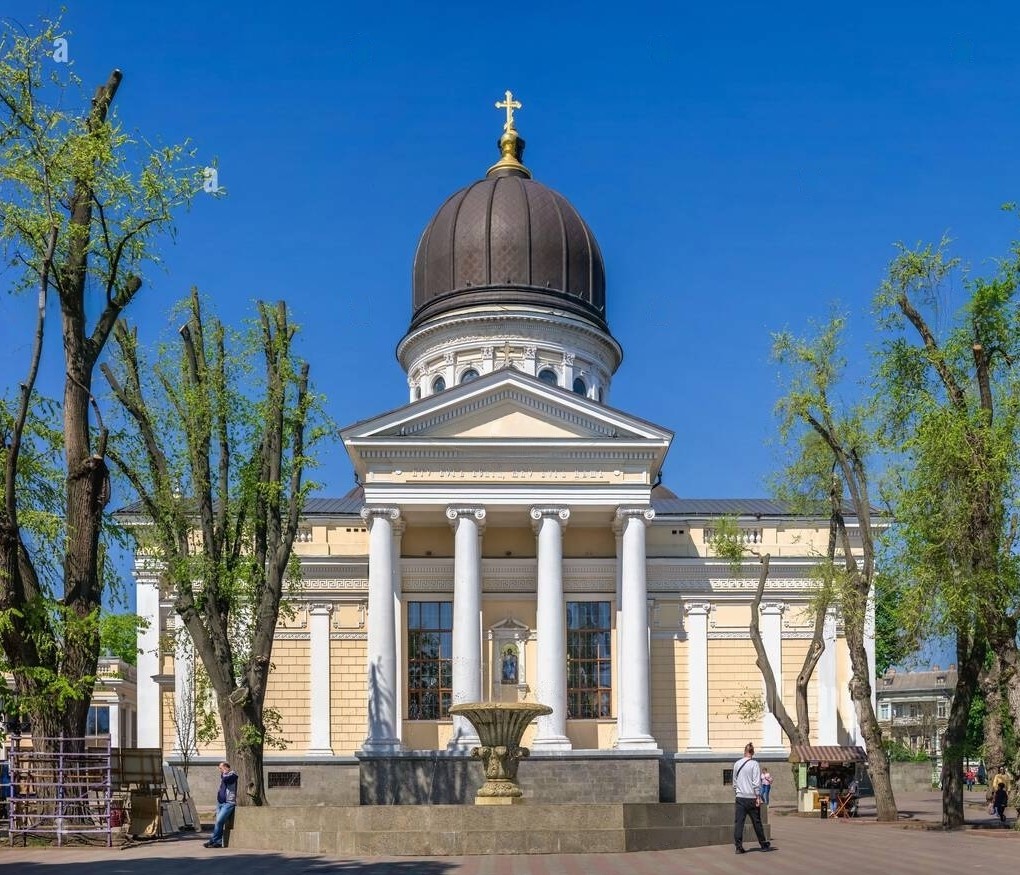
[0,0,1020,636]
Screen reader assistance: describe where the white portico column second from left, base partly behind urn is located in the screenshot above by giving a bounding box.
[447,507,486,750]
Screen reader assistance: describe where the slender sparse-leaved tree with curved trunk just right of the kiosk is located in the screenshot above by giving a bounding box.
[772,316,897,821]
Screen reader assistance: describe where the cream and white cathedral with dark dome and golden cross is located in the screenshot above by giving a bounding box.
[136,92,873,802]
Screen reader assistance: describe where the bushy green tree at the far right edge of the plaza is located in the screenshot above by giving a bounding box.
[876,230,1020,827]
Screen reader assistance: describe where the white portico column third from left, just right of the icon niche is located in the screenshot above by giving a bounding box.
[530,507,570,751]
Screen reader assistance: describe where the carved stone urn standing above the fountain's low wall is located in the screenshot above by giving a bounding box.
[450,702,553,805]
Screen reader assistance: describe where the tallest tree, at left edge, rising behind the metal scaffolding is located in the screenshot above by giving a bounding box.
[0,15,202,750]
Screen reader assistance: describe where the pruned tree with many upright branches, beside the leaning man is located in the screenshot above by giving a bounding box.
[103,292,326,805]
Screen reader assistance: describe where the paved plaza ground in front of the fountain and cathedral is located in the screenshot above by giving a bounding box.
[0,793,1020,875]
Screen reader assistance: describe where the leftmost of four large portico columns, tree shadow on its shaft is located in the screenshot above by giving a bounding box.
[361,507,400,754]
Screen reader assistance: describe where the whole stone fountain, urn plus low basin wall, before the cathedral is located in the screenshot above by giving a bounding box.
[230,702,742,857]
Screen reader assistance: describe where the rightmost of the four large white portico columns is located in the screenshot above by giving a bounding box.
[616,507,658,751]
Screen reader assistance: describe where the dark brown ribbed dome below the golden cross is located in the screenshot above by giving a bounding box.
[411,167,609,331]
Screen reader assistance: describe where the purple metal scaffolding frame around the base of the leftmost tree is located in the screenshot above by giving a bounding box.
[7,735,113,847]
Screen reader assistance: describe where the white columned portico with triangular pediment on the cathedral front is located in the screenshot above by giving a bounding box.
[343,368,672,753]
